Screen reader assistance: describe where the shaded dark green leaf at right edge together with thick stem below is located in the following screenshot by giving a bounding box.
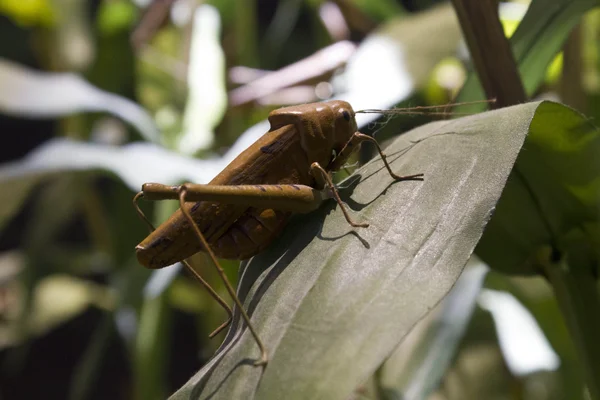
[477,103,600,399]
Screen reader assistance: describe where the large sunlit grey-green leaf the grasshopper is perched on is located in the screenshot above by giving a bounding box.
[173,103,546,399]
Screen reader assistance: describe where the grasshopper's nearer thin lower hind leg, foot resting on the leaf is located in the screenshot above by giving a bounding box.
[179,185,269,366]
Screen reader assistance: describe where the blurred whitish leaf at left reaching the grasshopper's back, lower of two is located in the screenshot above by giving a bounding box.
[0,139,220,233]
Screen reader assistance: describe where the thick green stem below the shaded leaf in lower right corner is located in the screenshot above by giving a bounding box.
[544,253,600,400]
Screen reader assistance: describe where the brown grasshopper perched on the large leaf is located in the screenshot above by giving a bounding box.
[134,100,423,365]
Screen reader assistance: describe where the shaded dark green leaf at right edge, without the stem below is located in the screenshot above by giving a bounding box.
[477,103,600,274]
